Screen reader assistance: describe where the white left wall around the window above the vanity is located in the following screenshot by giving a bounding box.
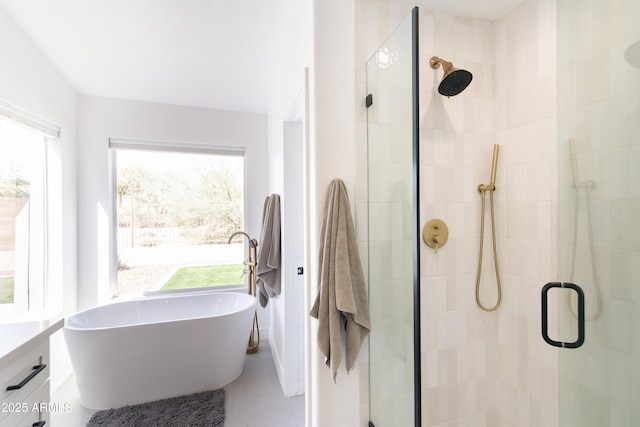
[0,9,77,390]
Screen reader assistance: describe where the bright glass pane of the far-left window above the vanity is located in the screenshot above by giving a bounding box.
[0,120,46,315]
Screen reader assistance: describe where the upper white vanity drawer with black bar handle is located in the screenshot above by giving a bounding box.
[0,340,49,419]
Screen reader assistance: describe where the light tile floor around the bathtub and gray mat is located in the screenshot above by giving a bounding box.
[51,340,304,427]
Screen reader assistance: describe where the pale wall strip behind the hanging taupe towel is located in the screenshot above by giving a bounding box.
[308,0,368,427]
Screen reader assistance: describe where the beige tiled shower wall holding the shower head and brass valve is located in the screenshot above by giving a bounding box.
[420,10,500,427]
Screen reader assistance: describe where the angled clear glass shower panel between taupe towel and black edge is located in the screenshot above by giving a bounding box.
[367,10,420,427]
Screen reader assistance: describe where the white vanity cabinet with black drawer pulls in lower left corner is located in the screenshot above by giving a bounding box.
[0,322,62,427]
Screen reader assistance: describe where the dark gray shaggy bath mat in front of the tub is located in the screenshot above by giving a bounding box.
[87,389,224,427]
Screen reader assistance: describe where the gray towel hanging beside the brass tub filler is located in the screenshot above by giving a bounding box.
[256,194,280,307]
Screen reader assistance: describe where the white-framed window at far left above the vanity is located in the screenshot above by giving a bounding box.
[0,102,61,319]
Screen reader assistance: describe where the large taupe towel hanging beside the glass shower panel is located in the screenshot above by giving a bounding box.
[309,178,371,381]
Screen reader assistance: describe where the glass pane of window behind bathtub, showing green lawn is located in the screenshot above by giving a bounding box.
[115,148,244,294]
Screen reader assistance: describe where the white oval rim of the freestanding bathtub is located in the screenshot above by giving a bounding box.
[62,291,258,332]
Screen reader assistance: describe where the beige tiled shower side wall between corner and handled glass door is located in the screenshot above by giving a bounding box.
[494,0,558,427]
